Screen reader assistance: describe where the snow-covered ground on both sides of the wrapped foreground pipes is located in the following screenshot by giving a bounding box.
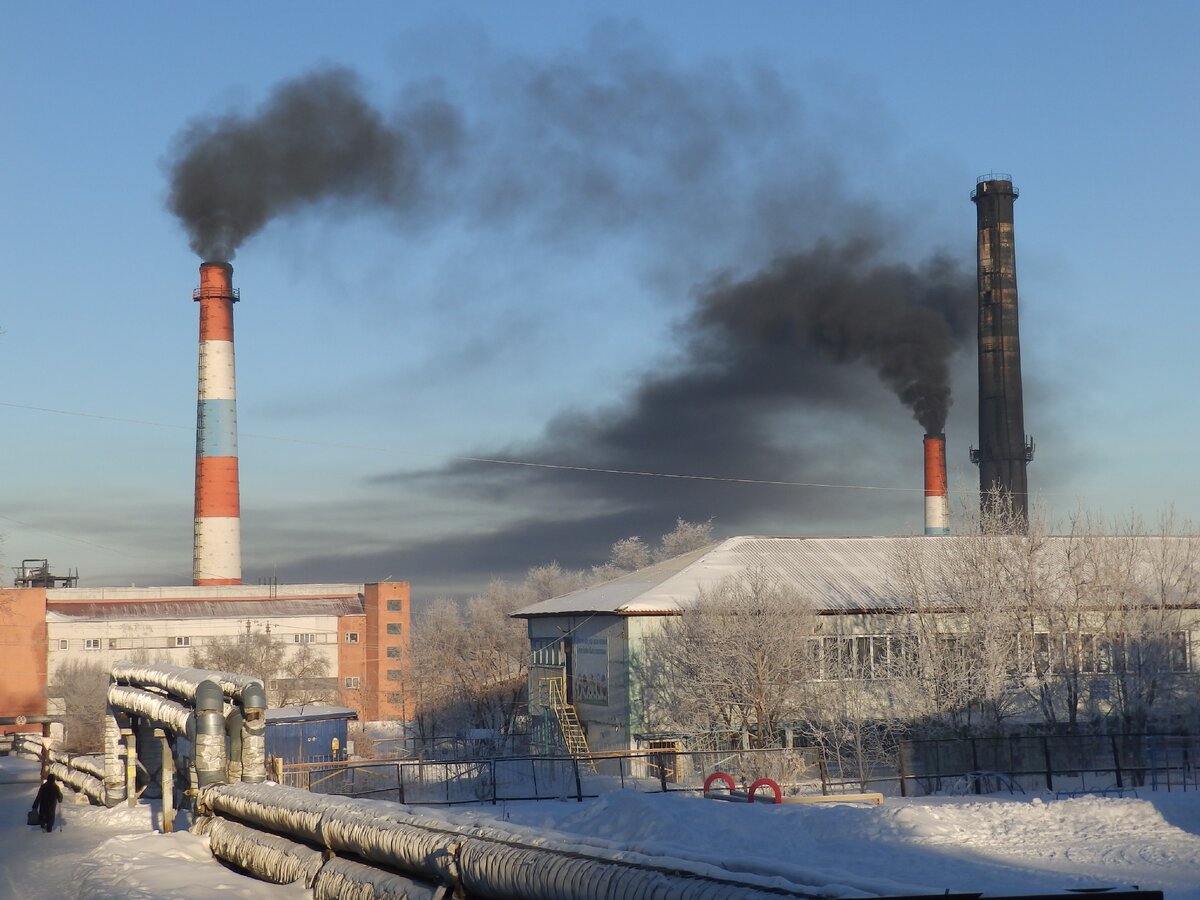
[0,758,1200,900]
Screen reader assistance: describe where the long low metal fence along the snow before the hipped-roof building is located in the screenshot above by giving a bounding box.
[280,734,1200,805]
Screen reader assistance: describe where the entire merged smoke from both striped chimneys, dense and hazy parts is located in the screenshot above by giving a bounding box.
[170,28,974,585]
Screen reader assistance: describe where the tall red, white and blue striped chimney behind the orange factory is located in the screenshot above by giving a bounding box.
[192,263,241,584]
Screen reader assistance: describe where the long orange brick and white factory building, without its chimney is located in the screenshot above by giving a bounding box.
[0,582,410,734]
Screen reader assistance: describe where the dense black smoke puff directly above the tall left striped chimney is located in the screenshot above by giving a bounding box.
[168,68,460,262]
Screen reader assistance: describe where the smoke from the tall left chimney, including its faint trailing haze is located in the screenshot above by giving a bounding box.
[167,26,877,266]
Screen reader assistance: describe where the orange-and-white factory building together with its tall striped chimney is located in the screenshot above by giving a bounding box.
[0,262,420,734]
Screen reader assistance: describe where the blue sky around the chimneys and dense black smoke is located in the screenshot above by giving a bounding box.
[0,2,1200,596]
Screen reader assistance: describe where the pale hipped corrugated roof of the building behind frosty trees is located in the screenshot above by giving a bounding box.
[514,536,1187,618]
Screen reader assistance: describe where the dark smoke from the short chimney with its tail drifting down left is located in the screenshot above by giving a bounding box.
[401,238,974,518]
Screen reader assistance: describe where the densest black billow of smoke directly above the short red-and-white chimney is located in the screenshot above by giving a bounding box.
[690,239,973,434]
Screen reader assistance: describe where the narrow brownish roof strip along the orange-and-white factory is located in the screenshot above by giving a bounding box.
[46,598,364,622]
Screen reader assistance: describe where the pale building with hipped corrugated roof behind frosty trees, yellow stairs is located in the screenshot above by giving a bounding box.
[514,536,1200,754]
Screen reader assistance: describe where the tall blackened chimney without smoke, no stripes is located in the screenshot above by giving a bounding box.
[971,174,1033,523]
